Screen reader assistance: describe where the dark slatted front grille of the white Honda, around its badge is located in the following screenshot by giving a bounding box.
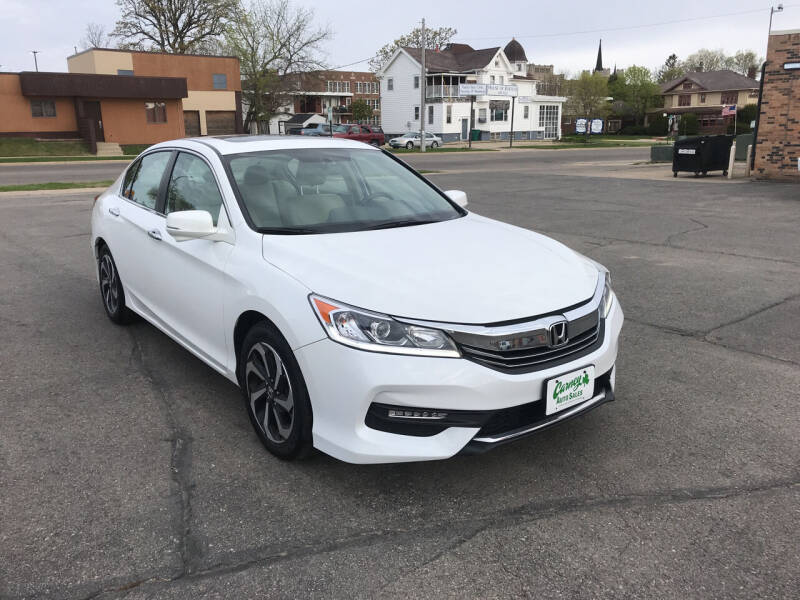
[459,322,605,373]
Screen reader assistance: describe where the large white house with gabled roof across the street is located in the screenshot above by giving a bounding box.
[378,40,566,141]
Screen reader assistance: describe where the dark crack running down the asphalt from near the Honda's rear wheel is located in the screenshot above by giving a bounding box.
[127,328,199,576]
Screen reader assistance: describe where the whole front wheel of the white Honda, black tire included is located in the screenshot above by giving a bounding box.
[238,321,313,460]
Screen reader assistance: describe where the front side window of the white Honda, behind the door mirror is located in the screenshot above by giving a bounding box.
[165,152,222,226]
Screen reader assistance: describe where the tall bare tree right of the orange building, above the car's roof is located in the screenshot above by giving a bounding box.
[226,0,331,129]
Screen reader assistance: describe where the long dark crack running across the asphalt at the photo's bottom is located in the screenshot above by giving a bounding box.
[61,472,800,600]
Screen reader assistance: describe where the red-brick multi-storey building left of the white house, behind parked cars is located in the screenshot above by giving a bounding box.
[270,71,381,133]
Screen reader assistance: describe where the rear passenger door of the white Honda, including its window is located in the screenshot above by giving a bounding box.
[106,150,173,313]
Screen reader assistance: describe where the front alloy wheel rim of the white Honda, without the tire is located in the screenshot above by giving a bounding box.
[245,342,294,444]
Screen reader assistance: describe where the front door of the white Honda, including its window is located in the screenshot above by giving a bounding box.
[151,150,233,369]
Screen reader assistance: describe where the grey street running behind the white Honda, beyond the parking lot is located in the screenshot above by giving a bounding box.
[0,148,650,186]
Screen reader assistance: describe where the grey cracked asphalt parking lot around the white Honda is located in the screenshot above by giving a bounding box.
[0,149,800,599]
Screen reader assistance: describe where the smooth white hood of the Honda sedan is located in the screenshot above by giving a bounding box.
[262,213,598,324]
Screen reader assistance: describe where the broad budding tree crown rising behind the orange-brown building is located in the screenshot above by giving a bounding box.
[112,0,239,54]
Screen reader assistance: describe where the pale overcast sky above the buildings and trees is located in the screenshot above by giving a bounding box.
[0,0,800,73]
